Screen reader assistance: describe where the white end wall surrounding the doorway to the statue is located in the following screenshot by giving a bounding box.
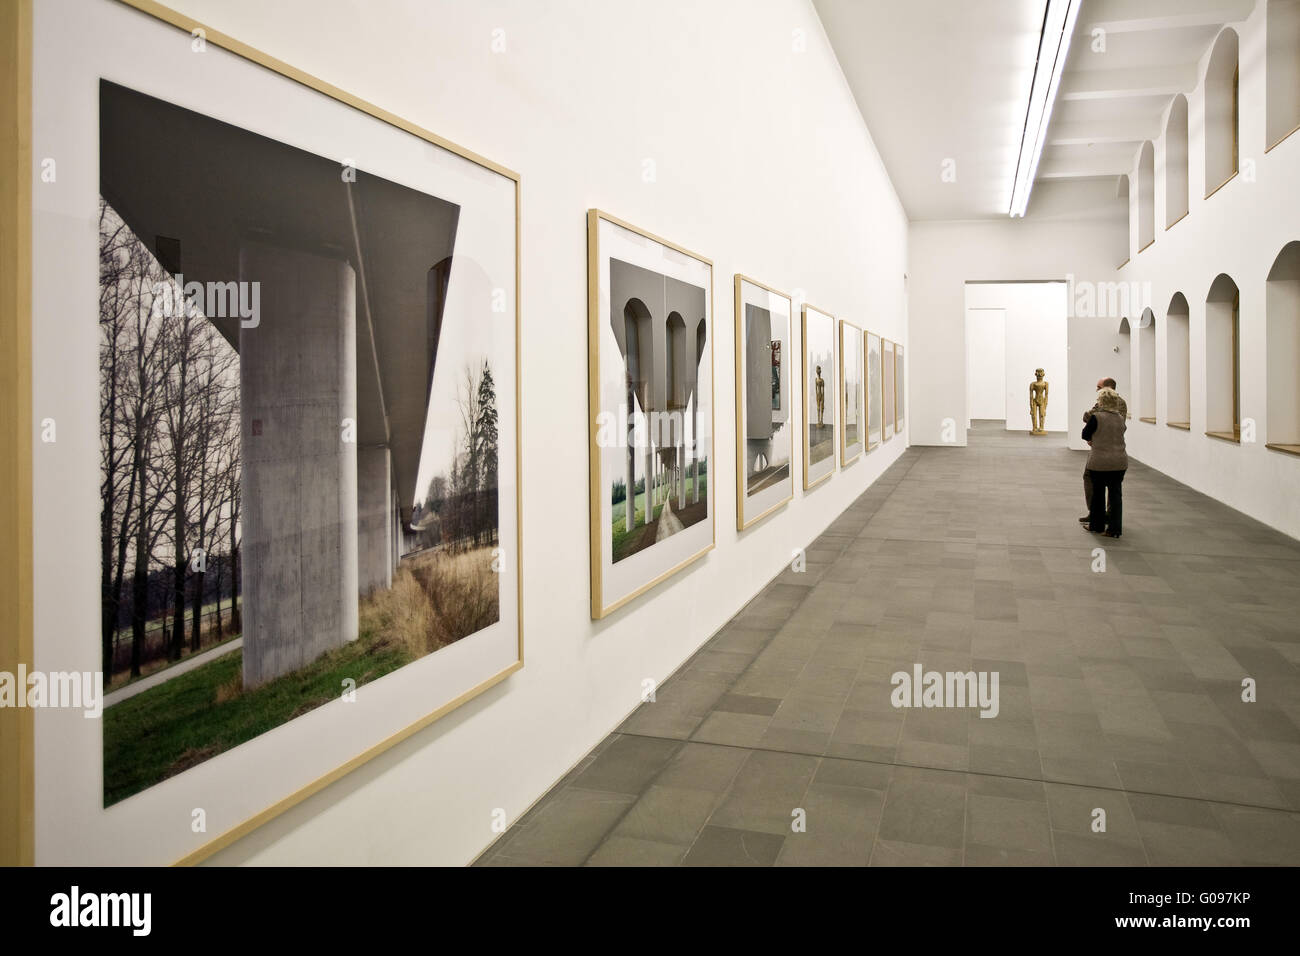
[907,197,1127,449]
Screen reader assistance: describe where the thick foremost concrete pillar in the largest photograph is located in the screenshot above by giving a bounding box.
[239,243,358,688]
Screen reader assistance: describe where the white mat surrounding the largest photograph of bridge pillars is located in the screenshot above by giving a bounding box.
[33,0,519,865]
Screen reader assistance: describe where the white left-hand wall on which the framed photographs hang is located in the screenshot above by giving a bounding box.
[139,0,904,865]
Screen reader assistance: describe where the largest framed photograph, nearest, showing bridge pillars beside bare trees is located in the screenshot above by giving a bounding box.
[25,0,523,865]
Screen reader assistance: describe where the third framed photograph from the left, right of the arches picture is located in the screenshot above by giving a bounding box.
[736,276,794,531]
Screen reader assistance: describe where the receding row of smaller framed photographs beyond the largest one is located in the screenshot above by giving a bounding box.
[588,209,904,619]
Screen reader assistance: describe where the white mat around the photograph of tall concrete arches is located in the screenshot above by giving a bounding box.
[594,219,718,607]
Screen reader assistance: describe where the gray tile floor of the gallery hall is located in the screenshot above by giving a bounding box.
[478,423,1300,866]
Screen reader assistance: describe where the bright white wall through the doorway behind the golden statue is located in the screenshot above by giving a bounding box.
[966,282,1070,432]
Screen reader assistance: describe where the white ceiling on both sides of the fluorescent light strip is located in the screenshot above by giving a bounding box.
[813,0,1255,220]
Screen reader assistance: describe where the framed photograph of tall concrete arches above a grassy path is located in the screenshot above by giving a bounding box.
[588,209,714,619]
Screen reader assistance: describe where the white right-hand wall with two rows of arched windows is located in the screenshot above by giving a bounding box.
[1118,0,1300,537]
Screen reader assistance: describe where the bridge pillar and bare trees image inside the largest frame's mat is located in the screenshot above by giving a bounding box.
[98,74,515,806]
